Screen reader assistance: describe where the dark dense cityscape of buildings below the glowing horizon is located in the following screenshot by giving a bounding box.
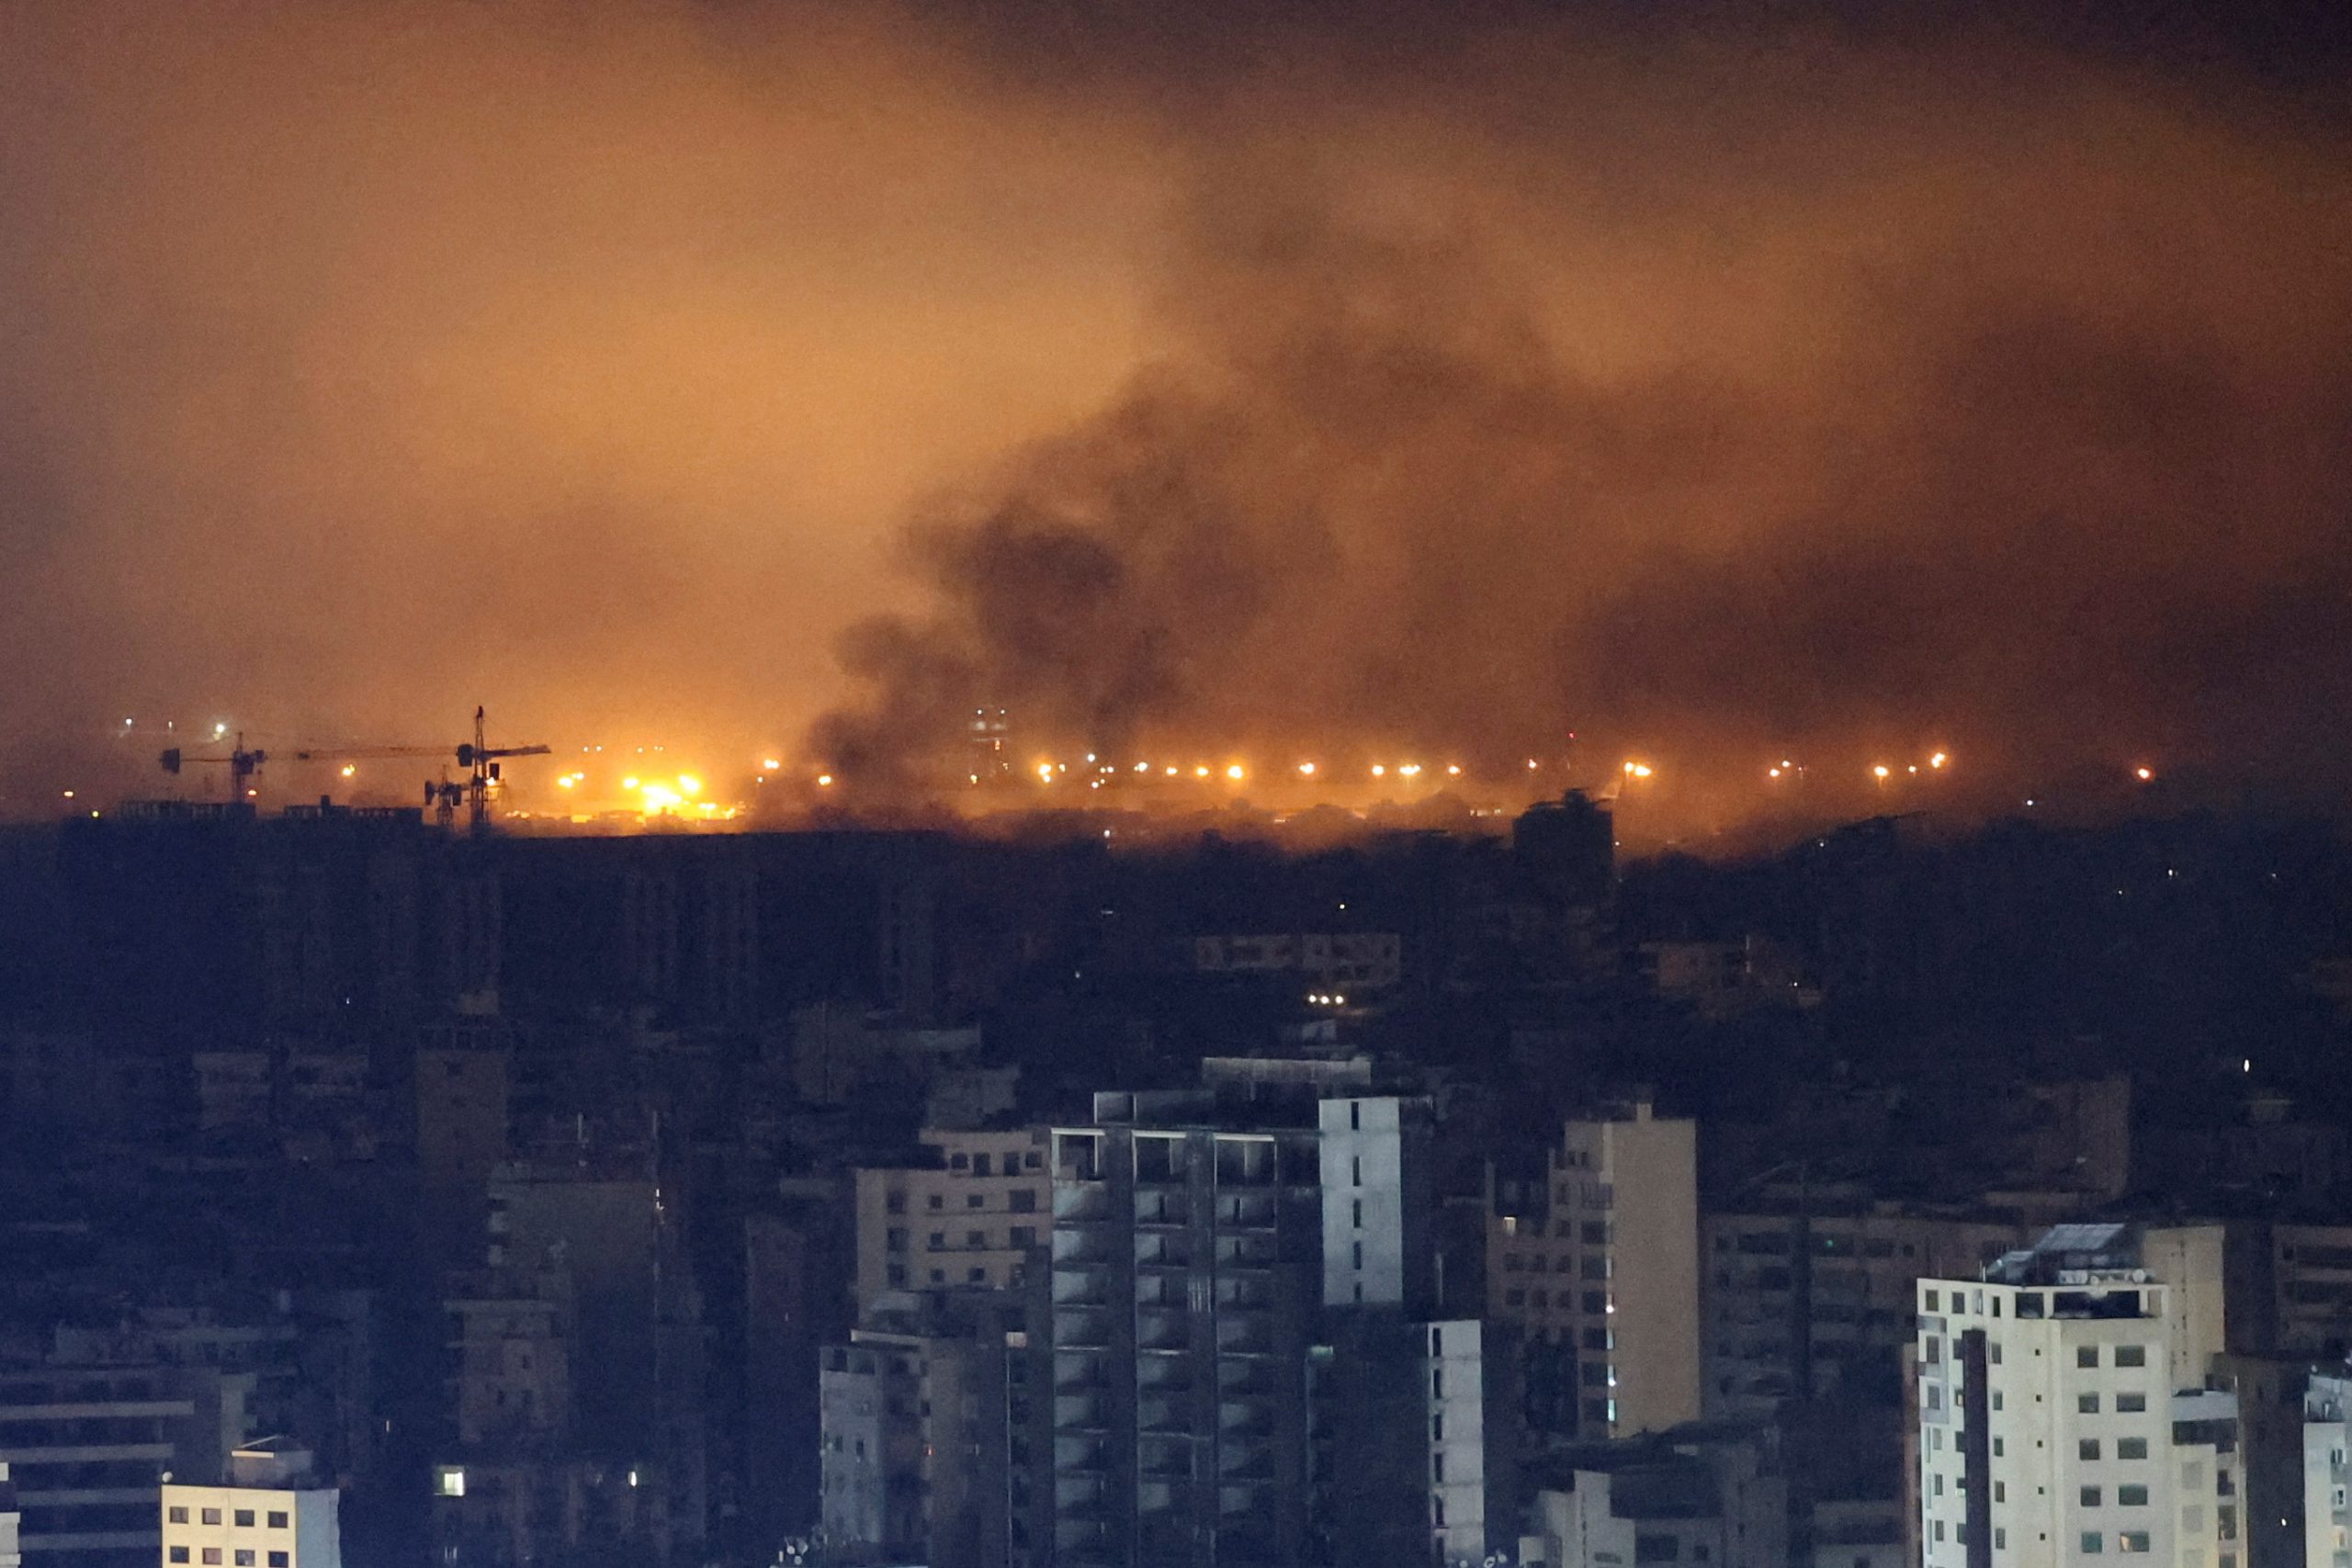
[0,792,2352,1568]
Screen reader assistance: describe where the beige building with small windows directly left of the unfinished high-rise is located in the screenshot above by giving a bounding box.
[856,1128,1051,1316]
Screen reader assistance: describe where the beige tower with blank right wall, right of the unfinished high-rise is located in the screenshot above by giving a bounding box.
[1487,1100,1701,1438]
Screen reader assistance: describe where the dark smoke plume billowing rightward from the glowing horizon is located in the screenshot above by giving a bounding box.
[819,28,2352,820]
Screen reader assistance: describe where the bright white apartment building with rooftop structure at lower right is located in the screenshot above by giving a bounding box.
[1917,1224,2242,1568]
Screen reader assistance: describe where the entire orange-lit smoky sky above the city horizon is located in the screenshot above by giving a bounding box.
[0,5,2352,827]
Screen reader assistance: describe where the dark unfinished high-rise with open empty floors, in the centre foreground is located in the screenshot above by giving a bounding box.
[1049,1090,1324,1568]
